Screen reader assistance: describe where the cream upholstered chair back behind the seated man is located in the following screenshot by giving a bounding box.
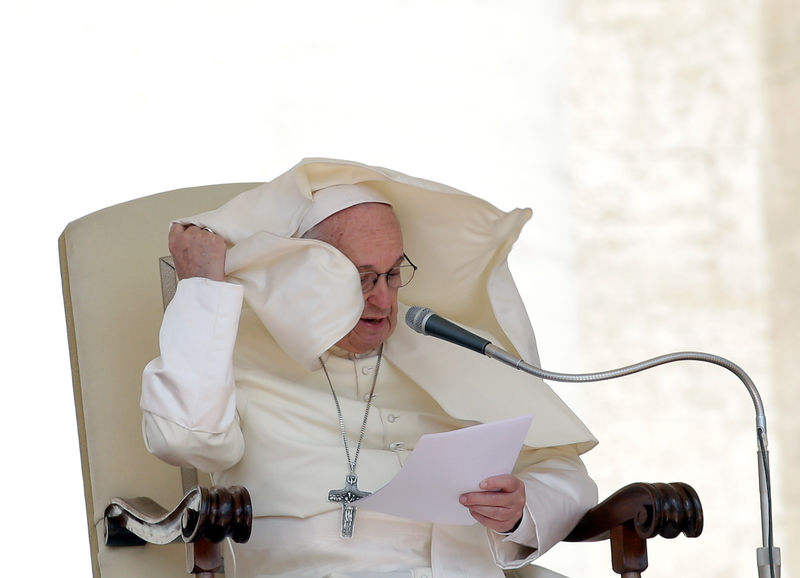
[59,183,257,578]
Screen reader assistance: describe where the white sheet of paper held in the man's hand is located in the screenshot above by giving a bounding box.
[354,415,533,526]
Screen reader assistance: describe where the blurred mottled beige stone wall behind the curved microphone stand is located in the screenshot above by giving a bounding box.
[534,0,800,578]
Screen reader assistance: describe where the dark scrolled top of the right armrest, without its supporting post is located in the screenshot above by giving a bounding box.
[565,482,703,542]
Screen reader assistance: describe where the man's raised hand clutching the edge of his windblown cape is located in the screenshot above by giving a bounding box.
[169,223,226,281]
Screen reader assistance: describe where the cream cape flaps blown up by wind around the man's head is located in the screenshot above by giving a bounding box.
[170,159,538,368]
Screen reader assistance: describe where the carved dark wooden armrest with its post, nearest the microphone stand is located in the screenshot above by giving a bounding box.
[564,482,703,578]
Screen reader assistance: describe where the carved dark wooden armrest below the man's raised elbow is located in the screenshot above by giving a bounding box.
[104,486,253,576]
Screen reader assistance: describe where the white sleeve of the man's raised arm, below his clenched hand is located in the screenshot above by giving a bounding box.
[140,278,243,471]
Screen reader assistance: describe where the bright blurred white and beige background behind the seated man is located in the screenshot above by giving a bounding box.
[0,0,800,578]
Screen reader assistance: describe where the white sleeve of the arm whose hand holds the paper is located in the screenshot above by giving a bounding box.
[487,446,597,569]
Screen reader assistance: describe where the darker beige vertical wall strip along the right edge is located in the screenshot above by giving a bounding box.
[761,0,800,575]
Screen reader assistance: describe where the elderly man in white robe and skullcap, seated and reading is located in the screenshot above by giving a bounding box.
[141,159,597,578]
